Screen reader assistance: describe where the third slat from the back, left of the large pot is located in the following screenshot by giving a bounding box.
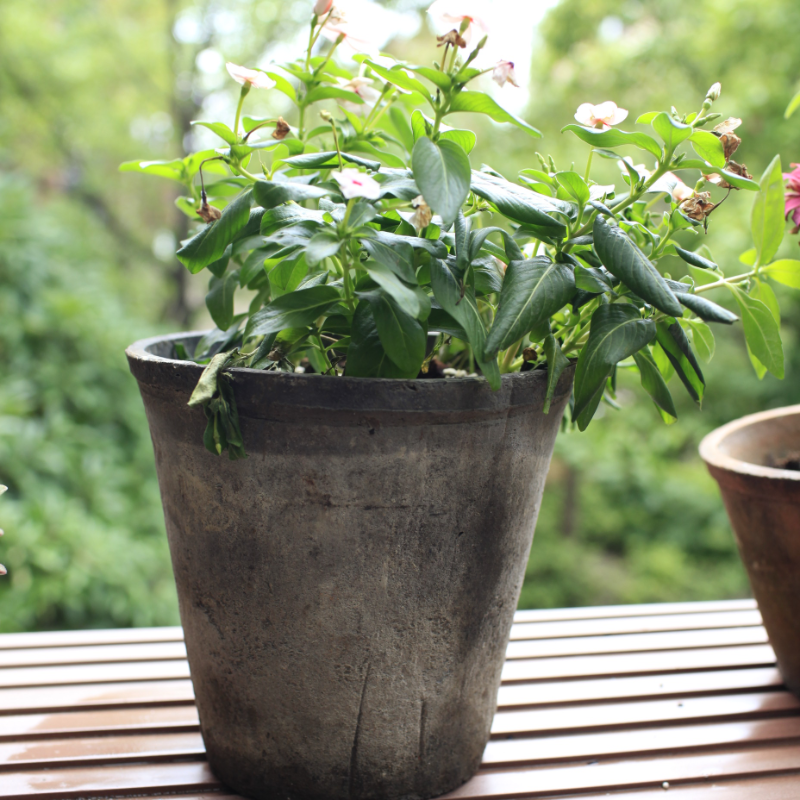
[0,661,189,688]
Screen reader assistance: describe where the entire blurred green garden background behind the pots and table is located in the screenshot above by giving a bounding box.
[0,0,800,631]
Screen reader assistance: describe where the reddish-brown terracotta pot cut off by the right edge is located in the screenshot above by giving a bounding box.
[700,406,800,694]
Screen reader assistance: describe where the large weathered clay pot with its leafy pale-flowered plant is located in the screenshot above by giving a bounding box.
[123,0,783,798]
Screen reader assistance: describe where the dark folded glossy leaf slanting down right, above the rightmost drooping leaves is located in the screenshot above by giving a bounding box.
[594,216,683,317]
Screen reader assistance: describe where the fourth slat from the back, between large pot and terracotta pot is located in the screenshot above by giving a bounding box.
[500,645,775,683]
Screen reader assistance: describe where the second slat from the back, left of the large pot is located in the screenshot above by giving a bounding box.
[0,642,186,674]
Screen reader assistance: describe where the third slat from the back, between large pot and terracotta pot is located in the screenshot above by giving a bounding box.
[506,626,768,659]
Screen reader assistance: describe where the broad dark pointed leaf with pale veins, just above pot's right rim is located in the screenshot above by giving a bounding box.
[484,256,575,358]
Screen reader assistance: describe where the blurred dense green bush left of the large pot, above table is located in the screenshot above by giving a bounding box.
[0,174,178,631]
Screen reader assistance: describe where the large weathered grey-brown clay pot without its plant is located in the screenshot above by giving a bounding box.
[127,334,572,800]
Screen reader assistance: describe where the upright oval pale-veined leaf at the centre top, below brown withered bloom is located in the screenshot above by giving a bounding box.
[411,136,471,226]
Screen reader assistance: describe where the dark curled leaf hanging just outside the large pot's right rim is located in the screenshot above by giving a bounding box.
[573,303,655,431]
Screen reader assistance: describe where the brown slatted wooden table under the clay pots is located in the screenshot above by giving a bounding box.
[0,600,800,800]
